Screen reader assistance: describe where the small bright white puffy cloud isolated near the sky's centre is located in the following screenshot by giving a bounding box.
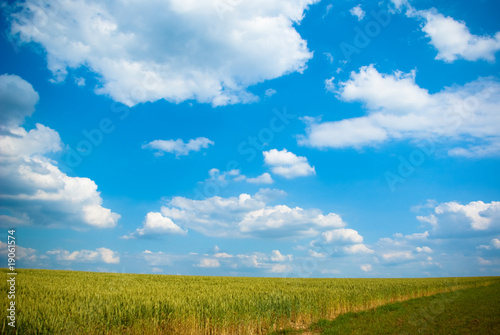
[263,149,316,179]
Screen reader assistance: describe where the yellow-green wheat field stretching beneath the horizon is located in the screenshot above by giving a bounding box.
[1,270,500,334]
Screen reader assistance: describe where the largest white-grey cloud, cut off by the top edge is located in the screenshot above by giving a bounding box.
[11,0,317,106]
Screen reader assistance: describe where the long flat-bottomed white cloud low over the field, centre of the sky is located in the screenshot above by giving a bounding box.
[135,189,345,238]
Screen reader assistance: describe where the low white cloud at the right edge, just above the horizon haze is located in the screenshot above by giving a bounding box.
[420,201,500,238]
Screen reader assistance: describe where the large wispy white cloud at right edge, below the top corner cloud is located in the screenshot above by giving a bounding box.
[298,65,500,157]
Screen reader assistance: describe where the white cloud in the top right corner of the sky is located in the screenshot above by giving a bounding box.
[406,5,500,63]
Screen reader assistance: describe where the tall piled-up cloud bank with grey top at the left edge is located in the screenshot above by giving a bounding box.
[0,75,120,228]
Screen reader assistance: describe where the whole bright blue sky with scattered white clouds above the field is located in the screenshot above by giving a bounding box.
[0,0,500,277]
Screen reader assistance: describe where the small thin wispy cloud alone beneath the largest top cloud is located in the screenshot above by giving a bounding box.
[142,137,214,157]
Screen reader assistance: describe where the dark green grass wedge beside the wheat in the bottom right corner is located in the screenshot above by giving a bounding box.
[292,282,500,335]
